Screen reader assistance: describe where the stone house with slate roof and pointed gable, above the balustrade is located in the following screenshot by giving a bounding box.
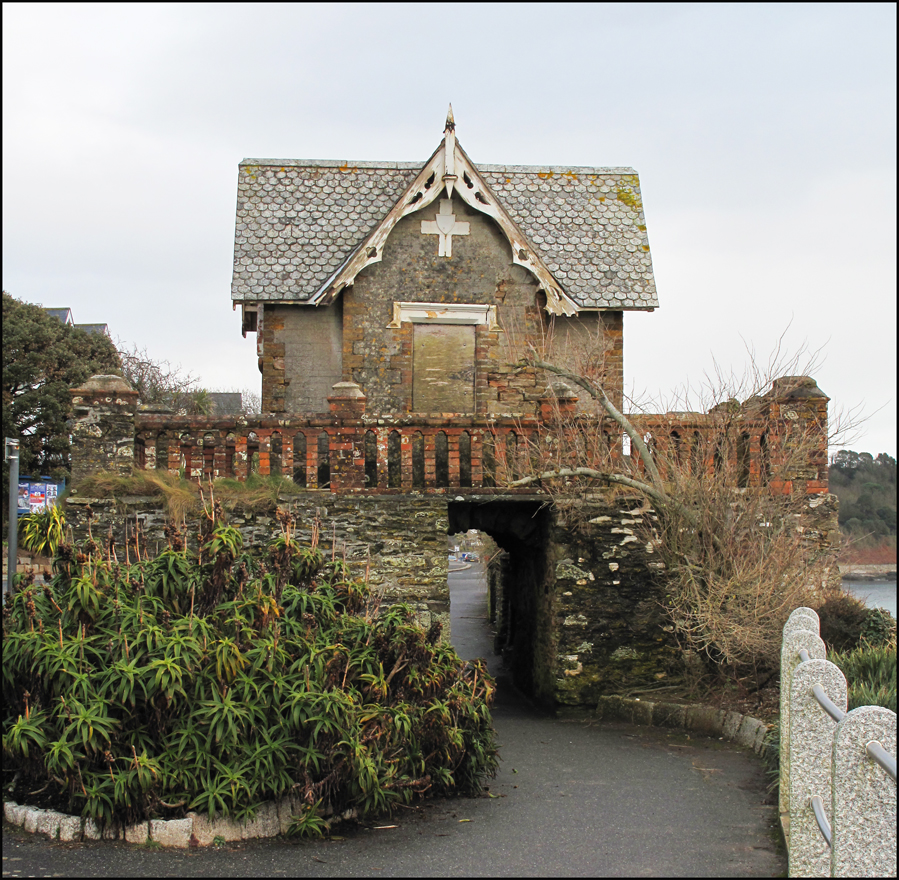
[231,108,658,416]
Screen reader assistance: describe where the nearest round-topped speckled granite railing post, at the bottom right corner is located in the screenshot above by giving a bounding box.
[831,706,896,877]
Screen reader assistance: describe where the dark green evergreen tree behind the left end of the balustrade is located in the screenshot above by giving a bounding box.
[3,291,120,519]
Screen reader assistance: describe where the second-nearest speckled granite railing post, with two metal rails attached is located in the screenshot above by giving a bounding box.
[788,660,847,877]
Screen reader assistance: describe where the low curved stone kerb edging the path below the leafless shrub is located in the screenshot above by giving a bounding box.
[596,696,770,755]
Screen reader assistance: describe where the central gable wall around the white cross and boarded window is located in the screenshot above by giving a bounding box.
[341,198,621,415]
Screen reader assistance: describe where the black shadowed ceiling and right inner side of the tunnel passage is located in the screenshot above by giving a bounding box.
[448,499,553,703]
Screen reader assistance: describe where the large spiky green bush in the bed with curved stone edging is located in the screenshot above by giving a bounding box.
[3,502,496,834]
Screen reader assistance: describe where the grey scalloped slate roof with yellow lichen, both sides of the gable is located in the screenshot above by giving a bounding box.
[231,159,658,309]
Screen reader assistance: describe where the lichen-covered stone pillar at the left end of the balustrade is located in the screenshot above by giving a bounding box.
[70,375,137,483]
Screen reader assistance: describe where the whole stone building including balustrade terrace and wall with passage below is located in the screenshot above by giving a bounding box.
[67,113,838,706]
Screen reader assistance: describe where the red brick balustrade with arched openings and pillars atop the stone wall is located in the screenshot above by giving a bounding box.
[72,377,828,494]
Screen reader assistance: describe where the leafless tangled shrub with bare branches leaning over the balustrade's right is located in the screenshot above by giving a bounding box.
[500,324,859,688]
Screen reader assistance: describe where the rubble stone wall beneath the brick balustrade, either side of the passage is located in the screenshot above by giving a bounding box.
[67,491,679,707]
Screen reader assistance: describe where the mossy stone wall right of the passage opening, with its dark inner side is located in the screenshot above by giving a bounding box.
[489,496,683,707]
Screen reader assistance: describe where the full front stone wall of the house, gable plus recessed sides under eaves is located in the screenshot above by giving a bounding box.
[258,199,623,415]
